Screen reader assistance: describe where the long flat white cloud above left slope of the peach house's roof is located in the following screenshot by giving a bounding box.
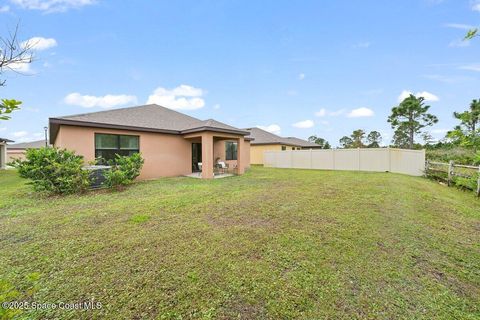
[64,92,137,108]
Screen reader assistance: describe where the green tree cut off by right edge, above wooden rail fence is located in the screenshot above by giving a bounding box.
[447,100,480,147]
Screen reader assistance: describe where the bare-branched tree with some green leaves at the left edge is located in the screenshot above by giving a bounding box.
[0,25,34,120]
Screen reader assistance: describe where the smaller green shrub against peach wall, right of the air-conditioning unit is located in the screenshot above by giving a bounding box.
[104,153,144,189]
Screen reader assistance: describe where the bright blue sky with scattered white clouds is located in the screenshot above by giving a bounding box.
[0,0,480,146]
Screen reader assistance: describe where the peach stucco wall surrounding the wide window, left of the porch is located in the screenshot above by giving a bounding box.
[54,125,192,179]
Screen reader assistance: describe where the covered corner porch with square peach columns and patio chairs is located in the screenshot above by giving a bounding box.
[184,131,246,179]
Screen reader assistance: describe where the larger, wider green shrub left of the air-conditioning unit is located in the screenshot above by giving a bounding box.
[11,148,90,194]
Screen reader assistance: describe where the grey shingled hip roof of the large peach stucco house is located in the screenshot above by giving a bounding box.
[50,104,249,141]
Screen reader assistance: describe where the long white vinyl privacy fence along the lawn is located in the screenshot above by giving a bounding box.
[263,148,425,176]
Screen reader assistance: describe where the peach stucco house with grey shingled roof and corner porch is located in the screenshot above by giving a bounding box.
[49,104,251,179]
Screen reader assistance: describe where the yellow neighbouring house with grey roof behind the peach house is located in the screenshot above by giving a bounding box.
[245,128,321,164]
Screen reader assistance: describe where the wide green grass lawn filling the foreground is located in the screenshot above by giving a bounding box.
[0,167,480,319]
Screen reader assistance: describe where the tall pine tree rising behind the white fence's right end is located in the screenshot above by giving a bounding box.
[388,94,438,149]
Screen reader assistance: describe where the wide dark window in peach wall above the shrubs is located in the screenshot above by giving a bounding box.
[95,133,140,161]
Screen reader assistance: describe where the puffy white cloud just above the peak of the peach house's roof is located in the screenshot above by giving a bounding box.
[147,84,205,110]
